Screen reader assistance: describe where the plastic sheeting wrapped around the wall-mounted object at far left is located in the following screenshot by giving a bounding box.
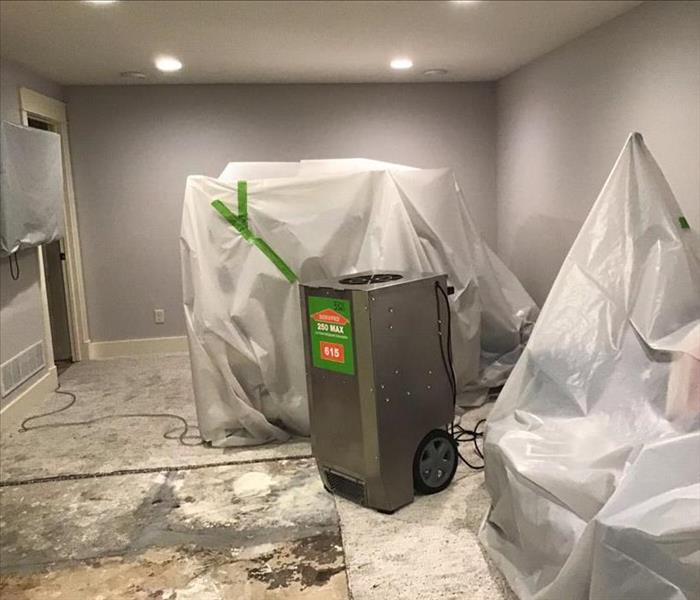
[0,121,64,255]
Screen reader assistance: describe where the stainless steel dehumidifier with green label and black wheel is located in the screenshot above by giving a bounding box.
[301,272,457,512]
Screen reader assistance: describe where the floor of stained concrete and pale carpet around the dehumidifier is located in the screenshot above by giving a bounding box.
[0,355,515,600]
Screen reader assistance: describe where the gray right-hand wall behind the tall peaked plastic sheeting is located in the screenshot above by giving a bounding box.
[498,2,700,303]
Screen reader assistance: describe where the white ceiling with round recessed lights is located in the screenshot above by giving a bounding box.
[0,0,640,84]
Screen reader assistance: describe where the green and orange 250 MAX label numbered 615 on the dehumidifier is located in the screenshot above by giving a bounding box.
[307,296,355,375]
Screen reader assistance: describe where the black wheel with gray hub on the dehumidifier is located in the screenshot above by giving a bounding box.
[413,429,457,494]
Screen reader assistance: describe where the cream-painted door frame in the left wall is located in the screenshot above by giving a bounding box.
[19,87,90,366]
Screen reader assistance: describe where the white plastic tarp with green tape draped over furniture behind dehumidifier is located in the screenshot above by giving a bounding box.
[181,159,537,445]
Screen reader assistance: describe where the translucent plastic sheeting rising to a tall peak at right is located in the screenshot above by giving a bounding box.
[481,134,700,600]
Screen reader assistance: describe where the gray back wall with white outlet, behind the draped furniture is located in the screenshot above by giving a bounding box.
[66,83,496,341]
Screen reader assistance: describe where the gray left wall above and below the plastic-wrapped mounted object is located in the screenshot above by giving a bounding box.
[0,59,63,370]
